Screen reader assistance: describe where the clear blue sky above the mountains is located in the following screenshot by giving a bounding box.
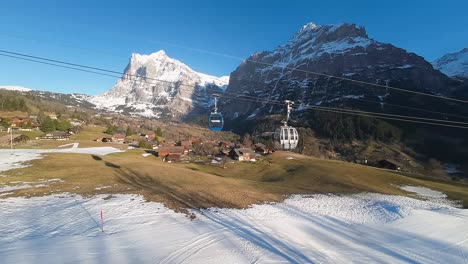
[0,0,468,94]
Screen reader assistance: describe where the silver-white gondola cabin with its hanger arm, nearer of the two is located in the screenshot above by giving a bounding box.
[274,100,299,150]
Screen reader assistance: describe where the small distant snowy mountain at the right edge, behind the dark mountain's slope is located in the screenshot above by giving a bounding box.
[432,48,468,78]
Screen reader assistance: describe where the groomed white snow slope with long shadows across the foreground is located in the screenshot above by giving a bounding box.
[0,194,468,263]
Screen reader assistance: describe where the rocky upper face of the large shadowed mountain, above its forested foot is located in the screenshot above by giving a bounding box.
[223,23,462,118]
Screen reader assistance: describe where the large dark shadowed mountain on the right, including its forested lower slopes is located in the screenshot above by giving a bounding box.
[220,23,468,173]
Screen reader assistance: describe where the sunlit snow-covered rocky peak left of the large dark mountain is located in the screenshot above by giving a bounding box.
[90,50,229,118]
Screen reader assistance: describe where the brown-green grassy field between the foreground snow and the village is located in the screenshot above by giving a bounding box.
[0,150,468,210]
